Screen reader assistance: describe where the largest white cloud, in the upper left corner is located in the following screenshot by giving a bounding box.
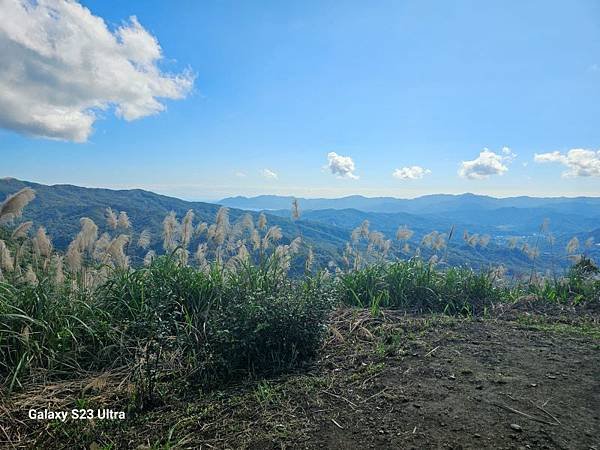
[0,0,194,142]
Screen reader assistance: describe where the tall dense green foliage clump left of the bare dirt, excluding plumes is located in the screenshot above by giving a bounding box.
[0,256,331,396]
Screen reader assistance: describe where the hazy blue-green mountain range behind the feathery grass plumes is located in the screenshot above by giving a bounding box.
[0,178,600,273]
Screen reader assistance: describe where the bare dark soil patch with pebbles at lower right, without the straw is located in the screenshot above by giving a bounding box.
[302,316,600,449]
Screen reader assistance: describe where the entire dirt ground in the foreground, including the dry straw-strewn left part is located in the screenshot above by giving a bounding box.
[0,310,600,450]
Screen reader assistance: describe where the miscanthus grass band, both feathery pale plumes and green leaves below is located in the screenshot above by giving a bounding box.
[0,189,600,398]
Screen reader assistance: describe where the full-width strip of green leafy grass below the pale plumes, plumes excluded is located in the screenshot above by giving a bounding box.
[0,256,600,405]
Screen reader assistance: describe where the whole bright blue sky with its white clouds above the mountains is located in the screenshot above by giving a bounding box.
[0,0,600,200]
